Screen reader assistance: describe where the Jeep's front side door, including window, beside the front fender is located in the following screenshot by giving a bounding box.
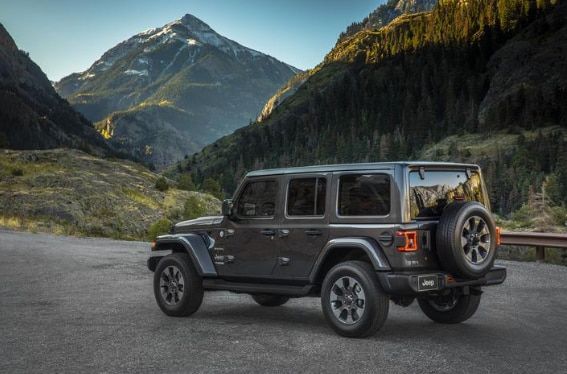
[217,178,281,279]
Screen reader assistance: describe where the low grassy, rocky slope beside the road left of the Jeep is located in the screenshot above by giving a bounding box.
[0,149,220,239]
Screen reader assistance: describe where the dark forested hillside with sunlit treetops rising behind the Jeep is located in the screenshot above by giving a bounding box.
[172,0,567,222]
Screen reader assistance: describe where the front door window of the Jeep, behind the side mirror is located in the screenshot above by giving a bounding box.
[237,180,277,218]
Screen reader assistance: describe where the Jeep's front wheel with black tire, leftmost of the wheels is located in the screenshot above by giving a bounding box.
[154,253,203,317]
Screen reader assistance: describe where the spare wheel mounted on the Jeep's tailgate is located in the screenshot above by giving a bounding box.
[435,201,496,279]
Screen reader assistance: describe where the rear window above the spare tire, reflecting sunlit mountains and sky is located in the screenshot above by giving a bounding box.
[409,170,486,219]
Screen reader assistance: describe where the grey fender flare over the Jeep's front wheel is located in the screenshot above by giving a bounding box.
[148,234,217,278]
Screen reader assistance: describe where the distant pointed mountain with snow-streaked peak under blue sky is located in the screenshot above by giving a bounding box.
[55,14,298,168]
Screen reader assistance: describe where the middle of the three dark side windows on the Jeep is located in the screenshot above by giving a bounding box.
[287,178,327,216]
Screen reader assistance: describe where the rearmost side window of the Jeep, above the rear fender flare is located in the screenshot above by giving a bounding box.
[338,174,390,216]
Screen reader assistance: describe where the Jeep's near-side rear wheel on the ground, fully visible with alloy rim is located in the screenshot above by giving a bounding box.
[321,261,389,338]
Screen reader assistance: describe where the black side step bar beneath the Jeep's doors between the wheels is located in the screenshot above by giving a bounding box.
[203,279,318,297]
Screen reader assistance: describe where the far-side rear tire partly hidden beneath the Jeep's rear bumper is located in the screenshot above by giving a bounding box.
[417,294,480,324]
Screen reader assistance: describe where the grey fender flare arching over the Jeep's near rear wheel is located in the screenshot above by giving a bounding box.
[309,238,392,283]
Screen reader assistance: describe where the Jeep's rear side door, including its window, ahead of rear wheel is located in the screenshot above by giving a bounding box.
[274,173,330,281]
